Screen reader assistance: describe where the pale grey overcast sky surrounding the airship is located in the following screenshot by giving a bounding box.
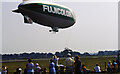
[2,1,118,53]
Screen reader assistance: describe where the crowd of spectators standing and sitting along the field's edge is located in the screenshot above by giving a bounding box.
[2,53,119,74]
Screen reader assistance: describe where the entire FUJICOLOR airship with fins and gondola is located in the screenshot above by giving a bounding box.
[12,0,76,32]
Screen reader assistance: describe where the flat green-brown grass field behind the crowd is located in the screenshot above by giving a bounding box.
[2,57,116,73]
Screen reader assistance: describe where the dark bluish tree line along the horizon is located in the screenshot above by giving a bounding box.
[1,48,118,60]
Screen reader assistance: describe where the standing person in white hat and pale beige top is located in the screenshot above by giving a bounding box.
[64,53,74,74]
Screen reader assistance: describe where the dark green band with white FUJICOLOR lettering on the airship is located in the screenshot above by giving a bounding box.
[20,3,75,20]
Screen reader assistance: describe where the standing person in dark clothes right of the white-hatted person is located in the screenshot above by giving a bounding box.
[74,56,81,74]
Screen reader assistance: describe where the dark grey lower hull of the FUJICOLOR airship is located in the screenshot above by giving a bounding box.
[24,10,74,28]
